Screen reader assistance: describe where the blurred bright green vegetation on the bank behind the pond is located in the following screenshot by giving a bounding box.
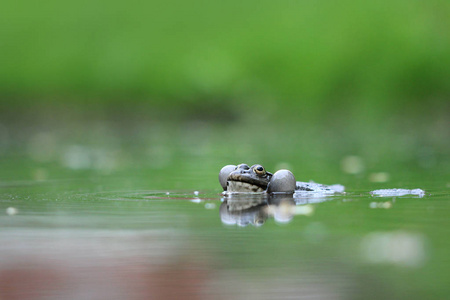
[0,0,450,118]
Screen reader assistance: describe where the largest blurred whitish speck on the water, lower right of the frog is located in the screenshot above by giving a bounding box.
[360,231,426,267]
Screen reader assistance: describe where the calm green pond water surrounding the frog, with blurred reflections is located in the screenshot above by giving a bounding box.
[0,120,450,299]
